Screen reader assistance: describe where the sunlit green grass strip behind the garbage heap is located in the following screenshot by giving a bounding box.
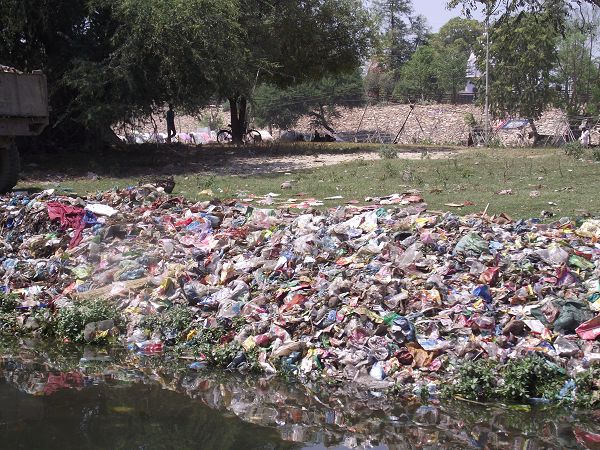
[18,147,600,218]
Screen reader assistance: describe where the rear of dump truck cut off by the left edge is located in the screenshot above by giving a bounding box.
[0,66,48,194]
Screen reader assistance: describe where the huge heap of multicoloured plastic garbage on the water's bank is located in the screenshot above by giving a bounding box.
[0,185,600,393]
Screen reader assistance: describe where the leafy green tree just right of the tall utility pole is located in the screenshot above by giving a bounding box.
[478,1,566,123]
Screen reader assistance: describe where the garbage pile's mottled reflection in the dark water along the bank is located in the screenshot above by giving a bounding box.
[0,347,600,449]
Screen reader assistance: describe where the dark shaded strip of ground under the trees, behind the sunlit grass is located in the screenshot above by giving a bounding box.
[22,142,454,182]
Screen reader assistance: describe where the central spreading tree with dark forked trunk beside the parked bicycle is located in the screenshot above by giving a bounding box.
[218,0,371,142]
